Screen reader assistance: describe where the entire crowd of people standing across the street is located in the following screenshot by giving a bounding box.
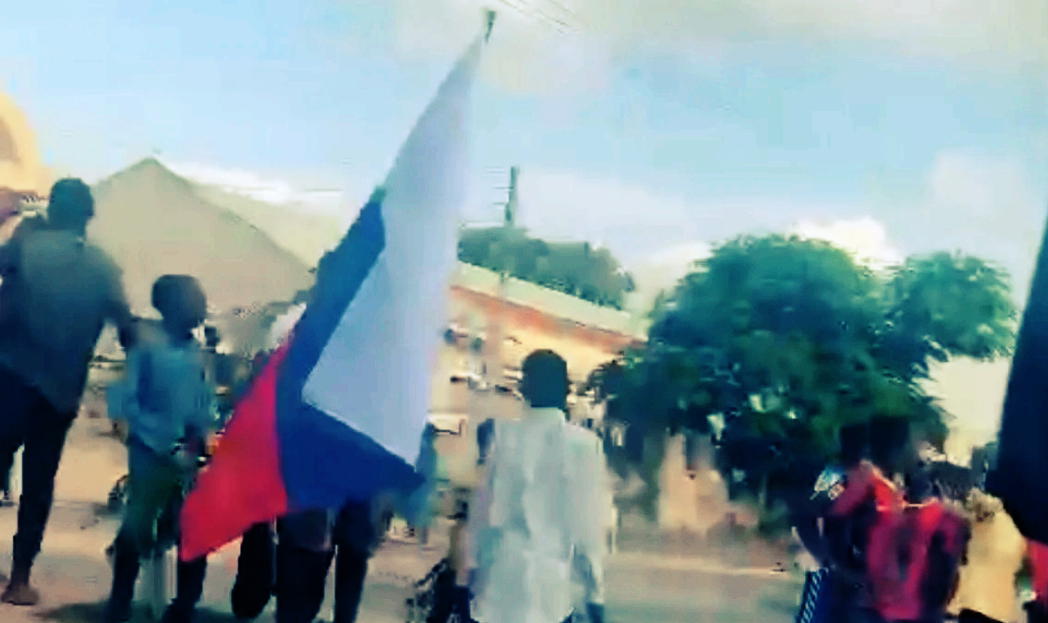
[0,174,1048,623]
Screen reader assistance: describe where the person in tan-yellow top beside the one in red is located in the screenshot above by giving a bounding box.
[951,489,1026,623]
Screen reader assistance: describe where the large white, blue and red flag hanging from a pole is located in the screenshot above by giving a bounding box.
[180,29,486,560]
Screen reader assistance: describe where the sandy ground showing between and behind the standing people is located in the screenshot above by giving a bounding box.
[0,409,799,623]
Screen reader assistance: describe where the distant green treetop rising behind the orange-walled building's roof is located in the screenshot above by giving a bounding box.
[458,228,634,309]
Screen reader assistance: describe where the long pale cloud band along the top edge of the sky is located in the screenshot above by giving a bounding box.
[387,0,1048,92]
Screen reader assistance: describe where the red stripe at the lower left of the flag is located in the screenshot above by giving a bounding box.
[180,340,290,560]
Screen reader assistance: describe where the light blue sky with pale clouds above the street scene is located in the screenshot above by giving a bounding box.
[0,0,1048,291]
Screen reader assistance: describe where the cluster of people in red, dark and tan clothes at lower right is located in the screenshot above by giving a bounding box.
[793,417,1048,623]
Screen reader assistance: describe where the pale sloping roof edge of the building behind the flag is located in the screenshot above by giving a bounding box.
[452,262,648,340]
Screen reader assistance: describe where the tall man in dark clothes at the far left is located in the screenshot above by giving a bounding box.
[0,179,132,605]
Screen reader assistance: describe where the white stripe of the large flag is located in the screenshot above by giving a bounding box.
[303,34,483,463]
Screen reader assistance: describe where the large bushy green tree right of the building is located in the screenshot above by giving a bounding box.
[591,235,1016,503]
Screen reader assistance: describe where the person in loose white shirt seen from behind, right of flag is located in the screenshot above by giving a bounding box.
[470,350,611,623]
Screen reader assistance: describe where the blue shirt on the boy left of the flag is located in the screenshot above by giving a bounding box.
[109,331,216,454]
